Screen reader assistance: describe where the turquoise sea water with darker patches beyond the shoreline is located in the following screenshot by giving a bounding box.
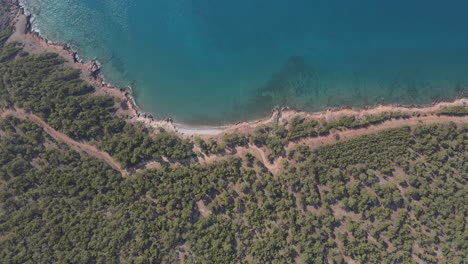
[22,0,468,125]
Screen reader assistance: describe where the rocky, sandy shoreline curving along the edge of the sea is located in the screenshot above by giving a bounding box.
[8,1,468,137]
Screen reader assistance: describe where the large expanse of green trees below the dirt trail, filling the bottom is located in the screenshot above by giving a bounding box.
[0,118,468,263]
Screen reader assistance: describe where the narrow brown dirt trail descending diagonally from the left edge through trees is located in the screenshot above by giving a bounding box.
[0,108,129,176]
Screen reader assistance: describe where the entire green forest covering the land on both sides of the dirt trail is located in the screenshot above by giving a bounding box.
[0,8,468,263]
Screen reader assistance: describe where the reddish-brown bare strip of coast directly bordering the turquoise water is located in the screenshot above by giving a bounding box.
[5,4,468,138]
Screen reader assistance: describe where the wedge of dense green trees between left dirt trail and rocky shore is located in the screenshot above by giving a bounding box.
[0,27,194,167]
